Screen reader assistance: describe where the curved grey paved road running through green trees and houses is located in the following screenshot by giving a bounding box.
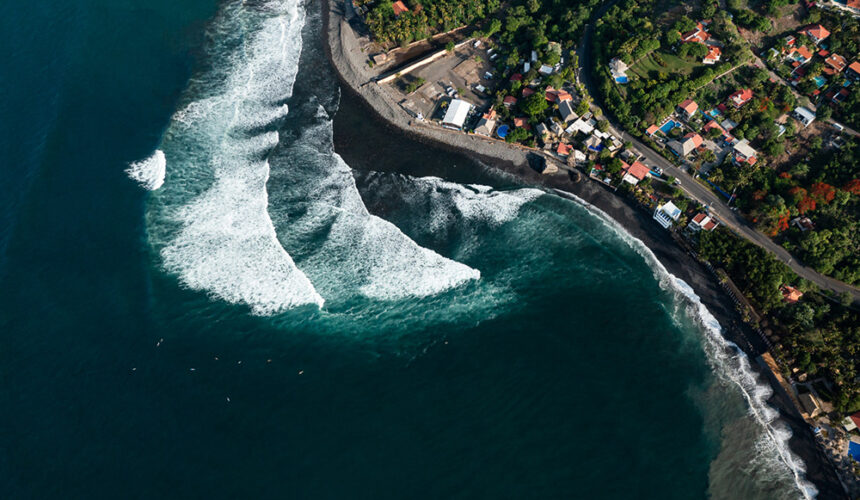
[577,15,860,304]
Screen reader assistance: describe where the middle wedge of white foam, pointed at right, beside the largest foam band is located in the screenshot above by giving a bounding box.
[271,110,481,300]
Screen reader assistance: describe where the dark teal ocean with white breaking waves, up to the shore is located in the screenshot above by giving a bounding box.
[0,0,816,499]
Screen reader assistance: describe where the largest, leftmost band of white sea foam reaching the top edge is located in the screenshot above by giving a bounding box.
[150,0,323,314]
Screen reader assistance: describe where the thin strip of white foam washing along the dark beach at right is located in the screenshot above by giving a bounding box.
[558,191,818,499]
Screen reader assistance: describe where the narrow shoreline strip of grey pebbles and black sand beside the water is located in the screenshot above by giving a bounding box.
[321,0,845,498]
